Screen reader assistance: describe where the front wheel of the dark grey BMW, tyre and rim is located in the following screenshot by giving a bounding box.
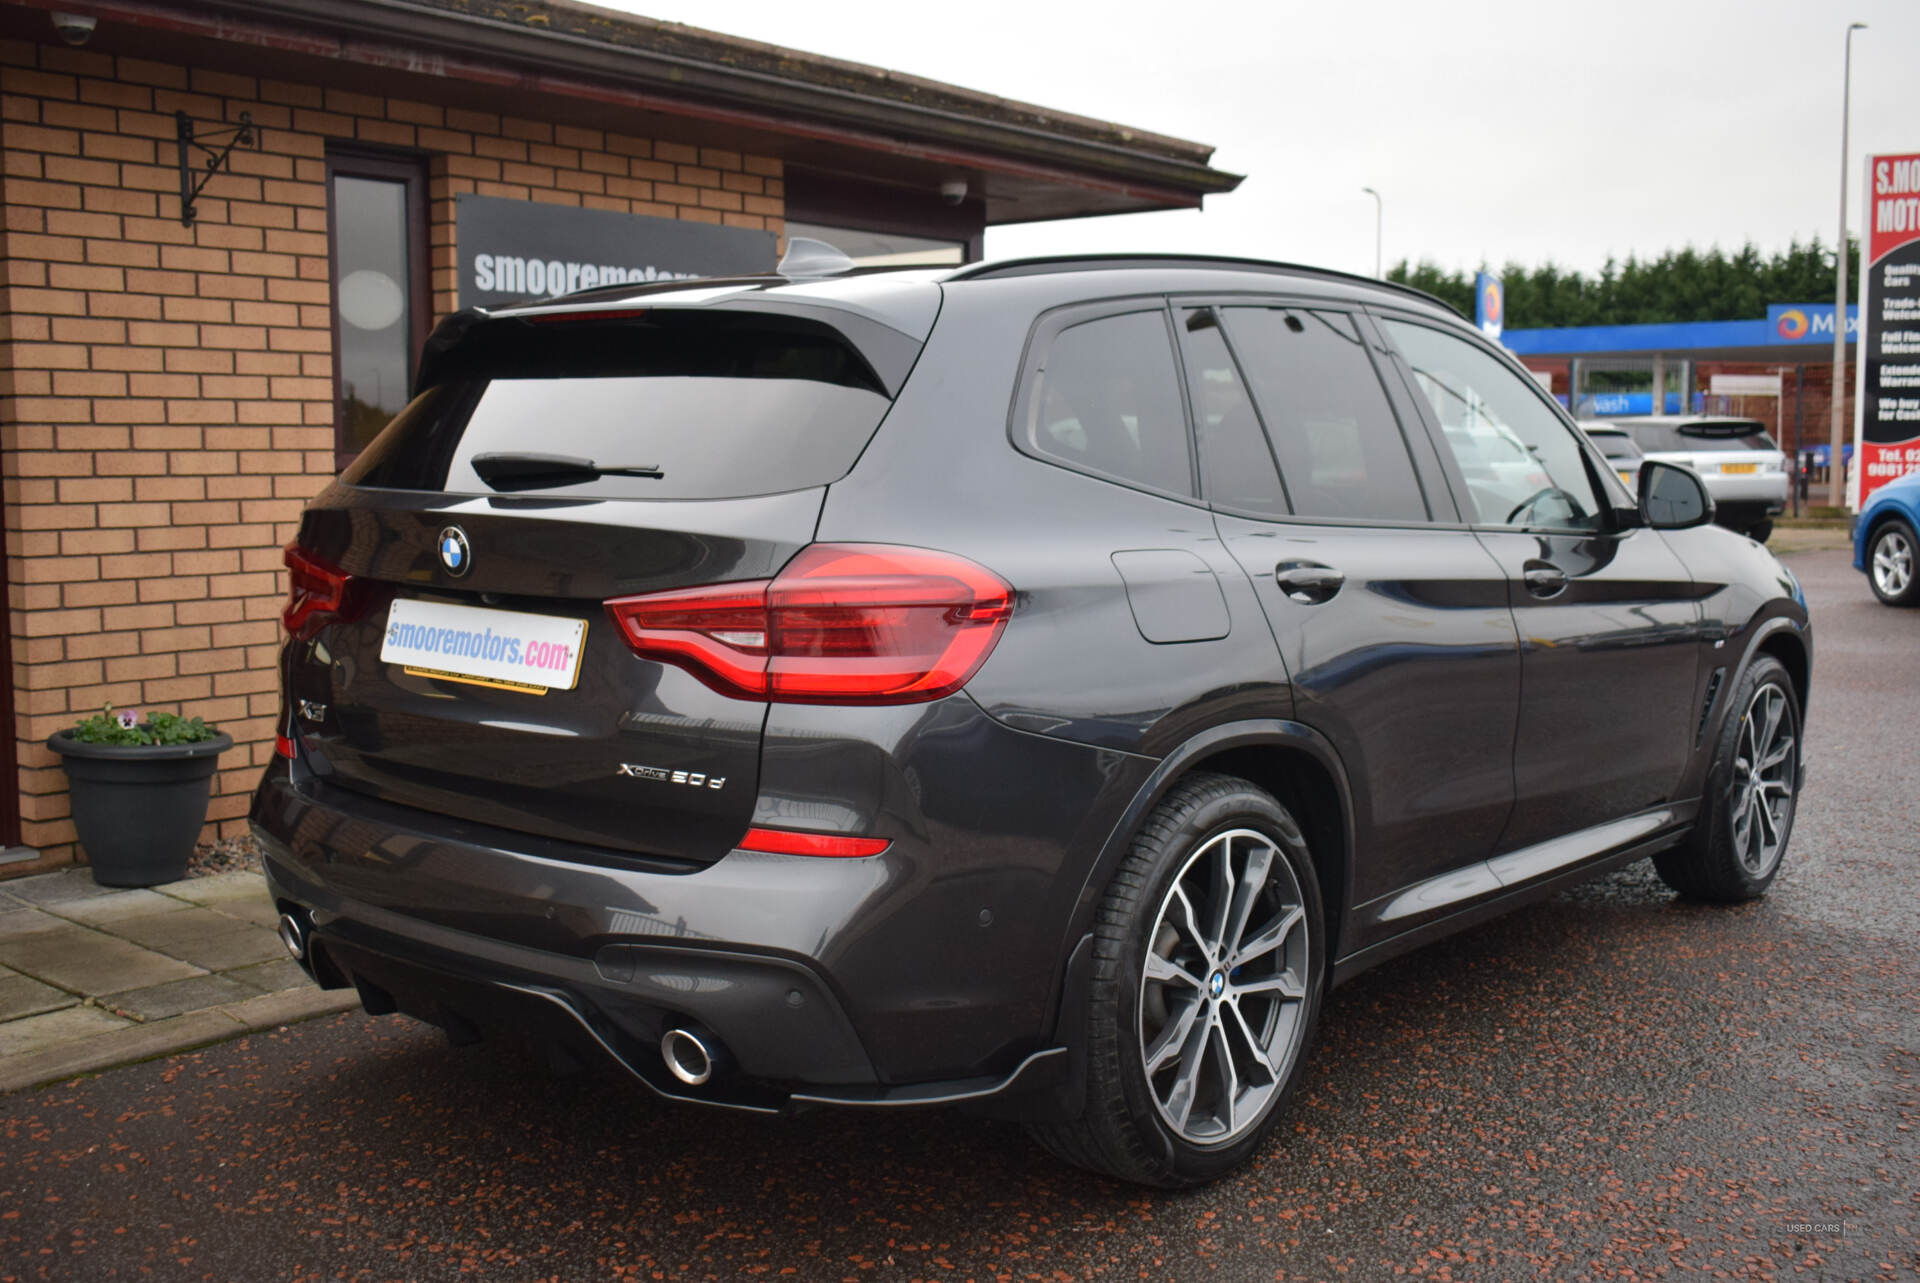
[1653,655,1801,903]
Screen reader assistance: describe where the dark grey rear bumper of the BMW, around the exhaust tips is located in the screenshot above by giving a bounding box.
[241,701,1148,1108]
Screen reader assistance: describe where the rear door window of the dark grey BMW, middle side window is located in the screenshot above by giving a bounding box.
[1223,307,1427,520]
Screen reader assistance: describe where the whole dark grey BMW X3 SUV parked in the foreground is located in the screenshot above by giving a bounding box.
[252,257,1811,1185]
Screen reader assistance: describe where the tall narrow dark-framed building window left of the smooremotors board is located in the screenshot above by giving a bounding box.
[326,152,432,467]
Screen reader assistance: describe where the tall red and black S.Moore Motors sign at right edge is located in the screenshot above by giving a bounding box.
[1851,154,1920,509]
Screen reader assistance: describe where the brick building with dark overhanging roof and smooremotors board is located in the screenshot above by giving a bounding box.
[0,0,1238,876]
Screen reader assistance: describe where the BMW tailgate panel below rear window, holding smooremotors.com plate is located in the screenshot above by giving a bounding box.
[288,490,822,860]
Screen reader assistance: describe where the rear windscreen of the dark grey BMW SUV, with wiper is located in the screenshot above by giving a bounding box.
[342,309,891,499]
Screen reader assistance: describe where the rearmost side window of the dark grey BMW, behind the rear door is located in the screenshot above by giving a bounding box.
[1023,307,1194,496]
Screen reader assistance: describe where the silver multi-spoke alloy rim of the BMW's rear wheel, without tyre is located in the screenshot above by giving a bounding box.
[1140,828,1311,1145]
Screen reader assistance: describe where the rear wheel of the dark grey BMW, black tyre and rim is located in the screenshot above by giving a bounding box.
[1031,774,1327,1189]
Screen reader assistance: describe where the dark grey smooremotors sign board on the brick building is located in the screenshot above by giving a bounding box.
[453,196,774,307]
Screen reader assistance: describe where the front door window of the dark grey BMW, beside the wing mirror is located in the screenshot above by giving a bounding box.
[1382,321,1601,530]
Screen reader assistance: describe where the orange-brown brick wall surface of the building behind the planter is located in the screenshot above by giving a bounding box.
[0,42,783,874]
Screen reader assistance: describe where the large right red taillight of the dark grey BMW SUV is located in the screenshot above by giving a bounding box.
[607,544,1014,703]
